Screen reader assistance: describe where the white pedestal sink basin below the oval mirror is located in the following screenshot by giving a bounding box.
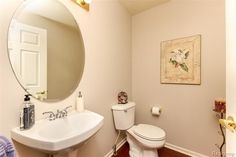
[11,111,104,152]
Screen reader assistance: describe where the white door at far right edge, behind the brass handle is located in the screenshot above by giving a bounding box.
[226,0,236,157]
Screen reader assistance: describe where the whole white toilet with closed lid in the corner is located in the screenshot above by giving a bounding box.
[112,102,166,157]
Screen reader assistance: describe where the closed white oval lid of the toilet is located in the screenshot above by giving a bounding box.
[133,124,166,141]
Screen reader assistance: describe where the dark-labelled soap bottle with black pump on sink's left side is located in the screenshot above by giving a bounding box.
[20,94,35,130]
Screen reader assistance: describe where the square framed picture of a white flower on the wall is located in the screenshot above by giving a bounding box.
[161,35,201,85]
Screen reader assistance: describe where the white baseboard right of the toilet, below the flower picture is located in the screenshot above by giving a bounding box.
[165,143,209,157]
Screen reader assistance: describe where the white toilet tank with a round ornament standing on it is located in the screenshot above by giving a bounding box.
[112,102,135,130]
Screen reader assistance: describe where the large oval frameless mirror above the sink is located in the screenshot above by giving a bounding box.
[8,0,85,102]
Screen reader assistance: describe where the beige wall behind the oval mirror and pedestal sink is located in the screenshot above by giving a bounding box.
[0,0,131,157]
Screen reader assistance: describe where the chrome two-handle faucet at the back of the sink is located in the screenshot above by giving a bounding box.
[43,106,72,121]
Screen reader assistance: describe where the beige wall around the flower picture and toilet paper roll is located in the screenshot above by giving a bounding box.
[132,0,226,156]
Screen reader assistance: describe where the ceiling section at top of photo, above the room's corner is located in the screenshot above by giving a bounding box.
[119,0,170,15]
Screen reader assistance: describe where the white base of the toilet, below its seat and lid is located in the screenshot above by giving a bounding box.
[127,134,158,157]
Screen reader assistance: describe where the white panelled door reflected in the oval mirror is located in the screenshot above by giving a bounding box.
[8,21,47,99]
